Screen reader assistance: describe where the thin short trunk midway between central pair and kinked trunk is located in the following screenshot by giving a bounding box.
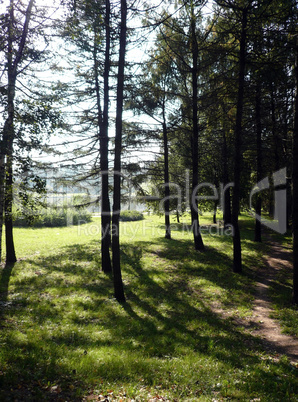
[162,118,171,239]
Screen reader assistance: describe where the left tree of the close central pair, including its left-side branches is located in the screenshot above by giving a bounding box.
[63,0,115,272]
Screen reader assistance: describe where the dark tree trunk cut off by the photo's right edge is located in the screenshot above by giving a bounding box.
[292,38,298,305]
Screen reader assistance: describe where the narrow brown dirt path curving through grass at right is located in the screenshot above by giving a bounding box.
[250,241,298,363]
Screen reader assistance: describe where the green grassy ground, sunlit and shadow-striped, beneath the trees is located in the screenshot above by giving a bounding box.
[0,216,298,402]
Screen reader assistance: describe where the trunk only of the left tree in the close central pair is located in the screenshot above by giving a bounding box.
[97,0,112,272]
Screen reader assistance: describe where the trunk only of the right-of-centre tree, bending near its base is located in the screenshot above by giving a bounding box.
[190,4,205,251]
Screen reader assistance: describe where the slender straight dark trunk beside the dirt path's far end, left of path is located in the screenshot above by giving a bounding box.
[254,81,263,242]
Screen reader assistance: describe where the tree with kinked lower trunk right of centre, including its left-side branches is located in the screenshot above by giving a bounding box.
[148,1,208,251]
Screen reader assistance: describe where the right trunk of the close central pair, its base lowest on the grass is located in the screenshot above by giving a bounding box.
[112,0,127,302]
